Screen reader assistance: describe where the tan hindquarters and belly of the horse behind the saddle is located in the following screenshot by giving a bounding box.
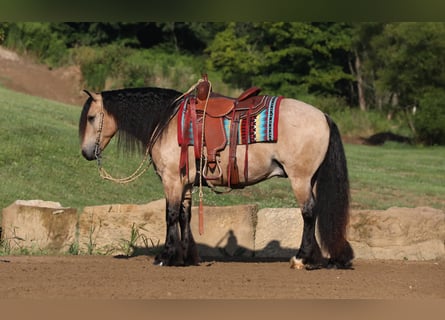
[221,99,330,184]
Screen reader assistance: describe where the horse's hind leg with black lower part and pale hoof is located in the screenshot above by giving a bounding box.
[291,179,327,269]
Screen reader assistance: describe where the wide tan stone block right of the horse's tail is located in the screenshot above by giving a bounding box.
[348,207,445,260]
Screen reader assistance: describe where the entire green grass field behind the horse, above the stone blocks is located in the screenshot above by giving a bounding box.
[0,88,445,214]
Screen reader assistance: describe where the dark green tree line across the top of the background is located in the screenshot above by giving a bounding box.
[0,22,445,144]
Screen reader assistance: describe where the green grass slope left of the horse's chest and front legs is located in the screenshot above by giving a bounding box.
[0,88,163,209]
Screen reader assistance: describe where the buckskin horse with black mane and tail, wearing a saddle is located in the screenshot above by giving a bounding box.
[79,78,354,269]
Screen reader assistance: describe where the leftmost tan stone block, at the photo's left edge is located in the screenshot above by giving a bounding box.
[2,200,77,253]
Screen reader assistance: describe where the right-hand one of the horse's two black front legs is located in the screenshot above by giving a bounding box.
[179,186,199,265]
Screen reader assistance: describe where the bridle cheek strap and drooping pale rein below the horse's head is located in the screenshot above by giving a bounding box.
[94,100,152,184]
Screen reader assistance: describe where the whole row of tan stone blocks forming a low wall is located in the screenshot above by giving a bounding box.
[1,199,445,260]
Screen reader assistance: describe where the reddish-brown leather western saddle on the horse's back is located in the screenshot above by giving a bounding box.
[180,75,269,188]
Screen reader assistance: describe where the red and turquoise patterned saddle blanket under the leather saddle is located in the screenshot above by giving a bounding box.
[178,96,282,145]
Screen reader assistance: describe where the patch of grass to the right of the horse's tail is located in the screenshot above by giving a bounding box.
[345,143,445,210]
